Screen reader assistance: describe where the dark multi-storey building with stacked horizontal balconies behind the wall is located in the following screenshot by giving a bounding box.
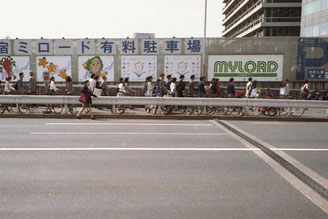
[222,0,302,37]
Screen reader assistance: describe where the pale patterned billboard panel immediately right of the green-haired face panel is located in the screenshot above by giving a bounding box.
[121,56,157,82]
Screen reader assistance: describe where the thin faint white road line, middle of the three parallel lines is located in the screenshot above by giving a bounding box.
[30,132,227,136]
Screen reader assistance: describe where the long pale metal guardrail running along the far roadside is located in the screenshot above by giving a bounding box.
[0,95,328,109]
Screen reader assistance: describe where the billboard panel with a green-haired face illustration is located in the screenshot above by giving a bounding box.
[79,56,114,82]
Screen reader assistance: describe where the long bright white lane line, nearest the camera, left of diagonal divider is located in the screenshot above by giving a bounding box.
[0,148,260,151]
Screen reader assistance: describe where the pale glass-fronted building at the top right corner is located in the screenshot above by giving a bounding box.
[301,0,328,37]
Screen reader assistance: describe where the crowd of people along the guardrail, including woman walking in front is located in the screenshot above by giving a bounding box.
[0,71,320,118]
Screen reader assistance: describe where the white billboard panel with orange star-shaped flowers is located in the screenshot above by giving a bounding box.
[36,56,72,82]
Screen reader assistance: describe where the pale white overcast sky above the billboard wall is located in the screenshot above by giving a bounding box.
[0,0,223,39]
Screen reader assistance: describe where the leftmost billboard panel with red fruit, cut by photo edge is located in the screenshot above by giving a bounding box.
[0,56,30,81]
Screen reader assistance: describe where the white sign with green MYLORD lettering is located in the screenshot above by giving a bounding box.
[208,55,284,81]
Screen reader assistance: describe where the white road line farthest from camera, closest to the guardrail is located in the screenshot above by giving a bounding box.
[46,122,213,127]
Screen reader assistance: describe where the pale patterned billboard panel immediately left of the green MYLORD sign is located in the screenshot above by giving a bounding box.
[164,55,202,80]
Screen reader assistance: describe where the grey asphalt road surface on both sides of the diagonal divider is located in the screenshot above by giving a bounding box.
[0,119,328,218]
